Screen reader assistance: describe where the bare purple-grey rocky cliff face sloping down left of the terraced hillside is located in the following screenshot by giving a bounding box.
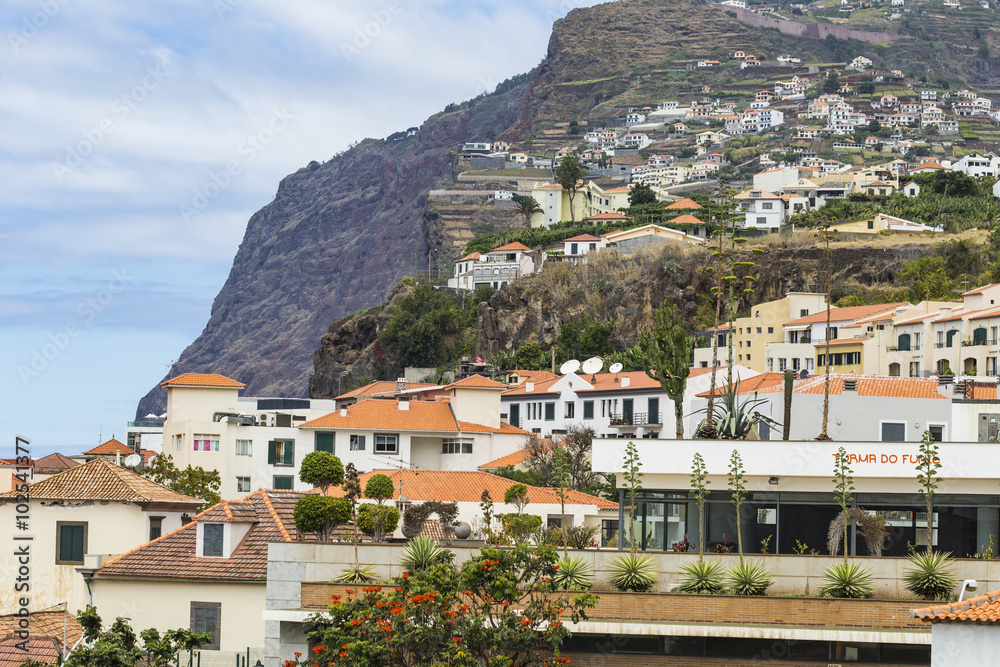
[136,86,526,415]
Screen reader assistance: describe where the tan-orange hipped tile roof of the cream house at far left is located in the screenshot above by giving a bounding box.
[0,459,202,506]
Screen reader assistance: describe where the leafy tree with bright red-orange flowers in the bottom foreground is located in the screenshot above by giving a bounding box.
[293,544,597,667]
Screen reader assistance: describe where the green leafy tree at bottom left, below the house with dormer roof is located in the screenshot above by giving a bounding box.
[64,605,212,667]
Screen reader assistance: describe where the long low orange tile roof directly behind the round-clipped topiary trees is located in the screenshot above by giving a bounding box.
[320,468,618,511]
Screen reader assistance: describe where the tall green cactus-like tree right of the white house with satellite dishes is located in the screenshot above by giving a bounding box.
[639,301,690,440]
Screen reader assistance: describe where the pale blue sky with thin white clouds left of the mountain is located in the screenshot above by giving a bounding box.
[0,0,597,457]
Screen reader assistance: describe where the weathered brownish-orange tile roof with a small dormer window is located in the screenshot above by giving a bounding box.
[94,489,305,583]
